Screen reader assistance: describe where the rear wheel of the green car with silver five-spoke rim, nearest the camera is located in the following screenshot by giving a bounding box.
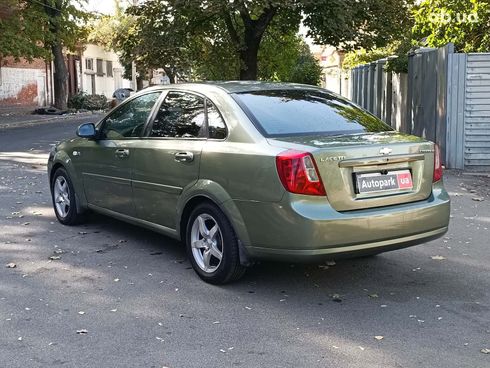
[186,202,246,285]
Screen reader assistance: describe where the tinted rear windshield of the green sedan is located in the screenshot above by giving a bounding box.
[233,89,392,137]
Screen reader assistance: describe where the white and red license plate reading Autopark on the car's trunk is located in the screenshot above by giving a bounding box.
[356,170,413,193]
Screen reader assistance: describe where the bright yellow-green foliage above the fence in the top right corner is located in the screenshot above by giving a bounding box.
[413,0,490,52]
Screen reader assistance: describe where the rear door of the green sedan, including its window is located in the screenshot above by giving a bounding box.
[132,91,207,229]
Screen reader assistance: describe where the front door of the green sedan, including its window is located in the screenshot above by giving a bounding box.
[76,91,162,217]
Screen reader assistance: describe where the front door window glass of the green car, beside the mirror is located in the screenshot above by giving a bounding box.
[100,92,161,139]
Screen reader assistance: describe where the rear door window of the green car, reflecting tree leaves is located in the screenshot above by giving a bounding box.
[150,92,205,138]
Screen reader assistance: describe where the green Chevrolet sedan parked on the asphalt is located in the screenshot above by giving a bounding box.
[48,82,449,284]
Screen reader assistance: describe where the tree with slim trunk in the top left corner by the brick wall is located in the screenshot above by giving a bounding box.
[0,0,88,109]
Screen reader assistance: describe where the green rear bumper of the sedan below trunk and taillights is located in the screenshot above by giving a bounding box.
[235,182,450,261]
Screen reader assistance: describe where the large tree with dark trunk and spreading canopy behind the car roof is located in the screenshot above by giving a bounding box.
[119,0,409,80]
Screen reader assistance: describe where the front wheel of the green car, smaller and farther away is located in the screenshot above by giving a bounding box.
[51,167,85,225]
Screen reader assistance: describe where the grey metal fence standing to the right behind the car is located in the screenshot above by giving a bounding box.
[351,44,490,170]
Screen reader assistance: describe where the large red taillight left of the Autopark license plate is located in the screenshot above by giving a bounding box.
[276,150,326,196]
